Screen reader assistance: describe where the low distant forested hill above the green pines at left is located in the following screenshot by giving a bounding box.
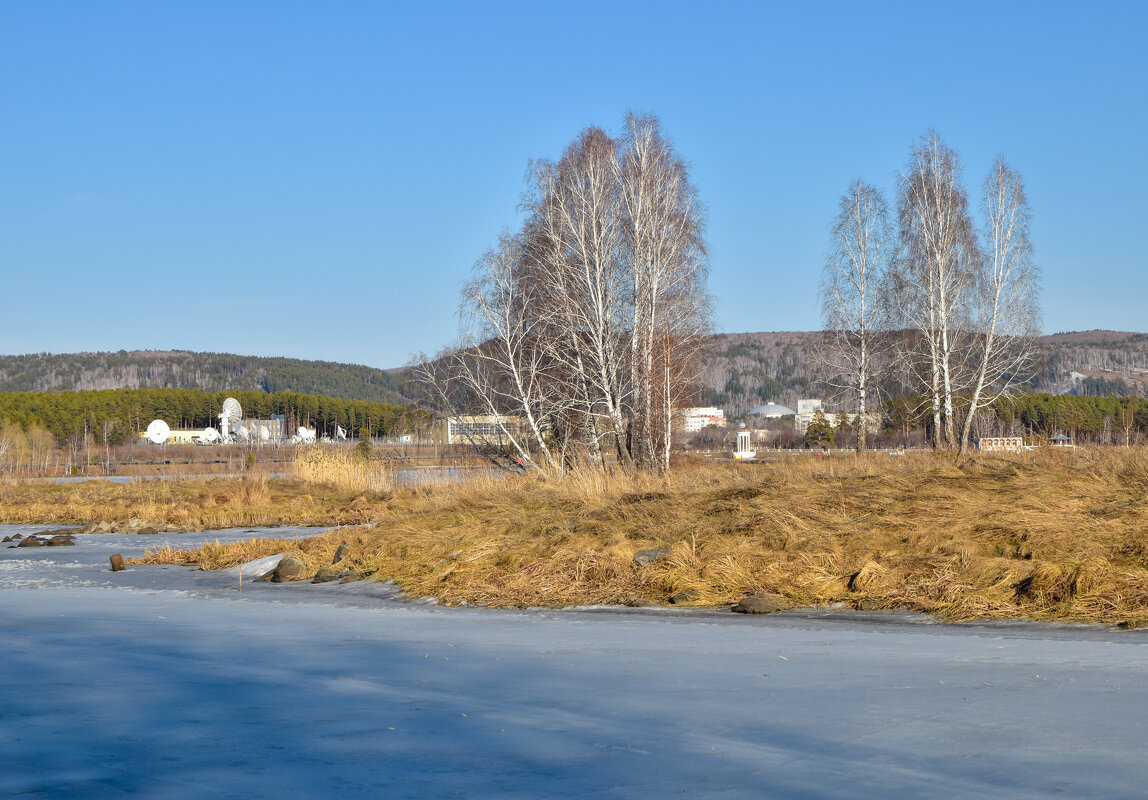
[0,350,410,405]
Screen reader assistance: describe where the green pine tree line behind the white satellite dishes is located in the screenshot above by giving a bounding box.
[0,389,427,444]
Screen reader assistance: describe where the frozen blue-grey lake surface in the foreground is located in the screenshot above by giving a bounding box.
[0,526,1148,799]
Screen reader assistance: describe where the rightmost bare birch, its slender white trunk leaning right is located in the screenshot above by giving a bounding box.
[960,157,1040,452]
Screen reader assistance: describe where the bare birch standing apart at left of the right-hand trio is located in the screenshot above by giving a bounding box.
[819,180,894,452]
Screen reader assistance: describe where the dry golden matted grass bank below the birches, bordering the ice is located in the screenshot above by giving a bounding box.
[123,450,1148,626]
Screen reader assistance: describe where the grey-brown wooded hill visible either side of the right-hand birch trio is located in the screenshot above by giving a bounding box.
[700,331,1148,417]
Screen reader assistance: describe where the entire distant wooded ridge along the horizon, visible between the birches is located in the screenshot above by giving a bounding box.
[0,328,1148,417]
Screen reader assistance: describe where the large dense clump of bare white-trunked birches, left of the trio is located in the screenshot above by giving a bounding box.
[418,114,709,469]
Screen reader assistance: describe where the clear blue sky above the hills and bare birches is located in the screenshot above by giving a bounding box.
[0,0,1148,367]
